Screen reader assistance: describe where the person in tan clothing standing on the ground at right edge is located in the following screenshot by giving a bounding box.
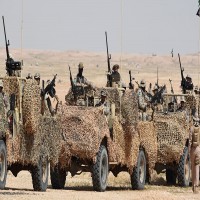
[190,117,200,193]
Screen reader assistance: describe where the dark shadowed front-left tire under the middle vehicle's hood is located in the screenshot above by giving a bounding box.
[50,163,67,189]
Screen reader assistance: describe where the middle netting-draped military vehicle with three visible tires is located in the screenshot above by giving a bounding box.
[50,87,157,191]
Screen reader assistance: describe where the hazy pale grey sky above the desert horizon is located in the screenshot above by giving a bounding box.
[0,0,200,54]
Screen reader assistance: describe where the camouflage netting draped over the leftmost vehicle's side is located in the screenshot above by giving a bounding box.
[3,77,62,165]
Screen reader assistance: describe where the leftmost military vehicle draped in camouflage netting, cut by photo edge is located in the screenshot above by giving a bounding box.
[0,76,60,191]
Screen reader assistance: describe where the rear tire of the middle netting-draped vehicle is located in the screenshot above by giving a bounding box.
[131,149,146,190]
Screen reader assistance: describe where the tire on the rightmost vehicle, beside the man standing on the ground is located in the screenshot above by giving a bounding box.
[177,147,191,187]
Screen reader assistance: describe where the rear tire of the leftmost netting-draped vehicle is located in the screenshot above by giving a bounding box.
[31,159,49,191]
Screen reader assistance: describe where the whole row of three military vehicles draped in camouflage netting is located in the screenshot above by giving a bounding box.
[0,19,195,194]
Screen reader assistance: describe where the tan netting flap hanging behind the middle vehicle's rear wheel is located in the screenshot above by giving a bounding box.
[137,121,158,173]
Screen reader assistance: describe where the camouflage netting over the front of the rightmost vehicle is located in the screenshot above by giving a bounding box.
[154,112,189,164]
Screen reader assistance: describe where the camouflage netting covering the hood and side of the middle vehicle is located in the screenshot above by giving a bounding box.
[62,88,157,172]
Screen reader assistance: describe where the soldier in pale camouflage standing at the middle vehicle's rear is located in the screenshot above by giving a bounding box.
[137,80,150,121]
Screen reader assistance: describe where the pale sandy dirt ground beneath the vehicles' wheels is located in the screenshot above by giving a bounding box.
[0,171,200,200]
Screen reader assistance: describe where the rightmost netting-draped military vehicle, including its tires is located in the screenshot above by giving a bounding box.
[153,94,192,186]
